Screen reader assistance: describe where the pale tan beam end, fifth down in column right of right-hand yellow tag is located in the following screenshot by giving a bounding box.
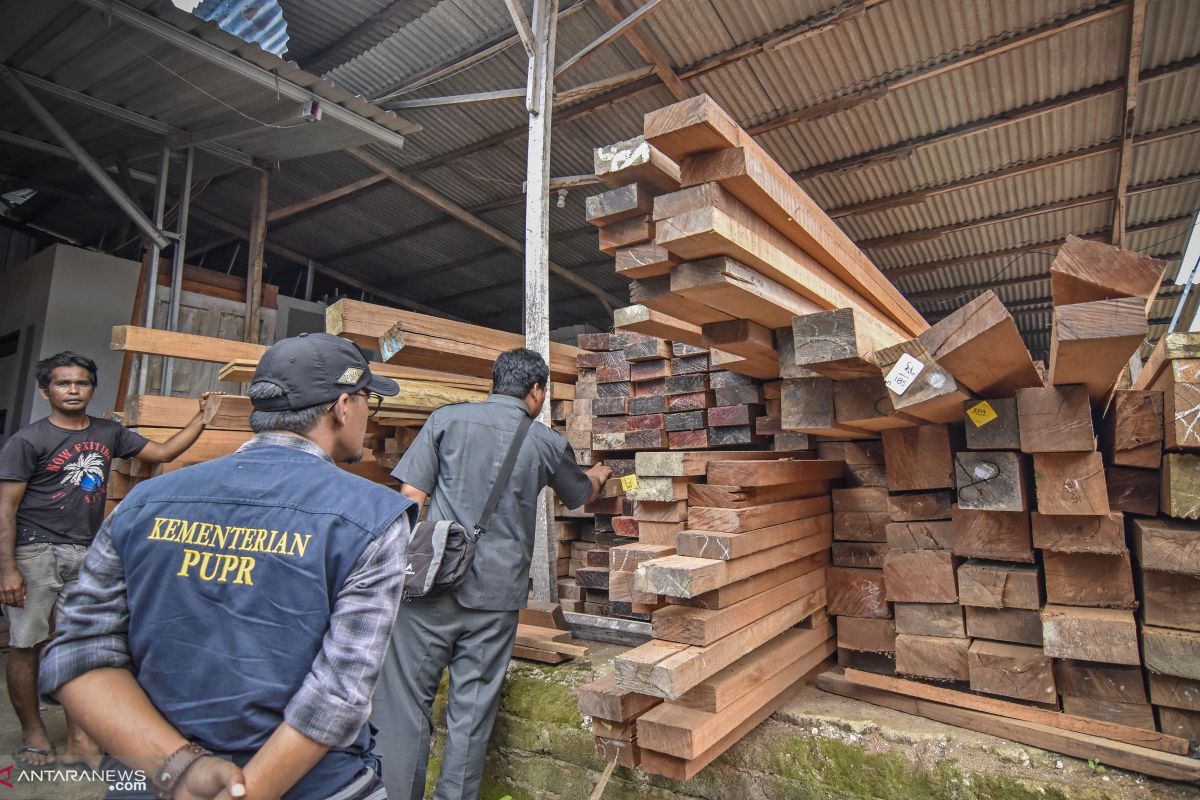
[1042,606,1150,667]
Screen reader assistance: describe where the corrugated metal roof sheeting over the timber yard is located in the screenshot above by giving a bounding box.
[7,0,1200,335]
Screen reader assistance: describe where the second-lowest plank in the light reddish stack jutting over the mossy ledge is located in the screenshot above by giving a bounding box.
[637,623,830,758]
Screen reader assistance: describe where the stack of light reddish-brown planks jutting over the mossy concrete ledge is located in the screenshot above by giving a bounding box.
[595,450,844,780]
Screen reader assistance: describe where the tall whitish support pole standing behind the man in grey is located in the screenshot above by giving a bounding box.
[523,0,558,602]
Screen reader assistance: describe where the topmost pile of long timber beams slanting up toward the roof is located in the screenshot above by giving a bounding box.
[587,95,929,388]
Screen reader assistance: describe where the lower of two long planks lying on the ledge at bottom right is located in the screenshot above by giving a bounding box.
[817,673,1200,781]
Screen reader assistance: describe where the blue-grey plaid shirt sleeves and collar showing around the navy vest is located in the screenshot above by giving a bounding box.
[38,433,410,747]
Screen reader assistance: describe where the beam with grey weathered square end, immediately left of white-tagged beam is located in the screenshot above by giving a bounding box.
[791,308,894,380]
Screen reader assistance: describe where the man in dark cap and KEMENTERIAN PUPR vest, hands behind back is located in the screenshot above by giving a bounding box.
[41,333,416,800]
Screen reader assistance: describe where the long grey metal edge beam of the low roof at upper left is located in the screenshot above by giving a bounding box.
[76,0,421,149]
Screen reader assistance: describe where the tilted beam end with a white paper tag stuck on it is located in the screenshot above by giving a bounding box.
[875,339,971,422]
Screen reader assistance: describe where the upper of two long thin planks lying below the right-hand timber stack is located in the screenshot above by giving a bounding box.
[845,669,1200,769]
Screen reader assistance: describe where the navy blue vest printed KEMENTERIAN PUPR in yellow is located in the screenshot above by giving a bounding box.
[112,445,412,800]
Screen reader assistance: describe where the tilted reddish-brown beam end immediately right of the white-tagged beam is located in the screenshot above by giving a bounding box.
[919,290,1042,397]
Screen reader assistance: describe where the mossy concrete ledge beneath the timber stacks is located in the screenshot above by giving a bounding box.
[405,644,1200,800]
